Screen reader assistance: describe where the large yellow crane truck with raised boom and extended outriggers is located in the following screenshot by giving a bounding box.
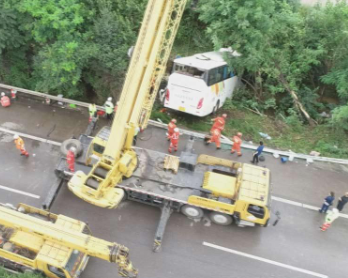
[64,0,270,251]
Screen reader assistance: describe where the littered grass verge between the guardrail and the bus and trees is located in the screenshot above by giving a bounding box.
[151,102,348,158]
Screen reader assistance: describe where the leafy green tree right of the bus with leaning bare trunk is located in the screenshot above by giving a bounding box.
[200,0,322,123]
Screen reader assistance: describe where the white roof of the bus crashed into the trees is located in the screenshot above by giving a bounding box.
[174,51,240,70]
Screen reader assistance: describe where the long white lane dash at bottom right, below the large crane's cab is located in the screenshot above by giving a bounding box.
[203,242,329,278]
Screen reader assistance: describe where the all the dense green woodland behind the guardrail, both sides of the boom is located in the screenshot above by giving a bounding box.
[0,0,348,130]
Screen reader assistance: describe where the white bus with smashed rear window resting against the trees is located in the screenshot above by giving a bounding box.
[160,50,240,117]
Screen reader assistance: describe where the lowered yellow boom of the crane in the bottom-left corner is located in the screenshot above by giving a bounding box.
[0,204,137,278]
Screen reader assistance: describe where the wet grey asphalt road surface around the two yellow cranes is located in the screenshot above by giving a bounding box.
[0,99,348,278]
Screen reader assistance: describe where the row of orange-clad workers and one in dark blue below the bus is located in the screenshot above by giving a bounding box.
[167,114,264,164]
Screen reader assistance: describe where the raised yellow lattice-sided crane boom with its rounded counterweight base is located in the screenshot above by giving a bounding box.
[68,0,187,208]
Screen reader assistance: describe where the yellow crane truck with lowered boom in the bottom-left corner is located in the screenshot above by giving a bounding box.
[0,204,137,278]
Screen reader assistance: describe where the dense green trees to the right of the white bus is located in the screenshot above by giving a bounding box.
[200,0,348,129]
